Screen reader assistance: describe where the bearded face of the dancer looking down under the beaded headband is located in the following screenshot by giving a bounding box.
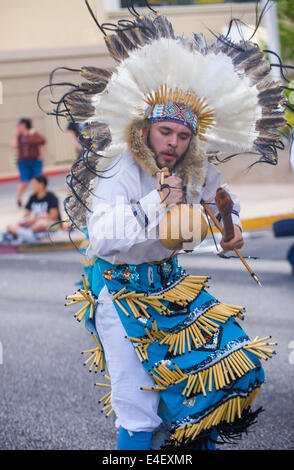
[142,121,192,169]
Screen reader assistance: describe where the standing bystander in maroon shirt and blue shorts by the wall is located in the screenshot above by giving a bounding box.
[11,118,46,207]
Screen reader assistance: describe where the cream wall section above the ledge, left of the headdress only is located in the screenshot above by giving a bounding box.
[0,0,104,51]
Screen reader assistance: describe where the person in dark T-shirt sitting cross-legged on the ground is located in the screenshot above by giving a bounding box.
[5,175,61,241]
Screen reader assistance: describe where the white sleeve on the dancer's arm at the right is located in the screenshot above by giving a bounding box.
[202,163,242,230]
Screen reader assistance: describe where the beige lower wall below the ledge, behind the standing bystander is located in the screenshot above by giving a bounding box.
[0,44,113,173]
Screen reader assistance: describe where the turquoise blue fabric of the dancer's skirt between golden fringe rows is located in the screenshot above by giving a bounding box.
[86,258,264,448]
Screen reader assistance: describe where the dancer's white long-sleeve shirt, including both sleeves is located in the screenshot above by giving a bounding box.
[87,151,241,264]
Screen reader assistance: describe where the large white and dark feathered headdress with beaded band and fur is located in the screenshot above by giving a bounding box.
[38,0,287,226]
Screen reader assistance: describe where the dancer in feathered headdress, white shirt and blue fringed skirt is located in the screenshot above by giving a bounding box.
[50,0,285,450]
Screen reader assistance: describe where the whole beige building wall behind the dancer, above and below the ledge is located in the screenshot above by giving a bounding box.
[0,0,291,181]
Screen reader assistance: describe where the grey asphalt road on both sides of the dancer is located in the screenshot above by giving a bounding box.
[0,232,294,450]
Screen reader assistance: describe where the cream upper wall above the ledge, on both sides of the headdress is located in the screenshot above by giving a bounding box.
[0,0,262,51]
